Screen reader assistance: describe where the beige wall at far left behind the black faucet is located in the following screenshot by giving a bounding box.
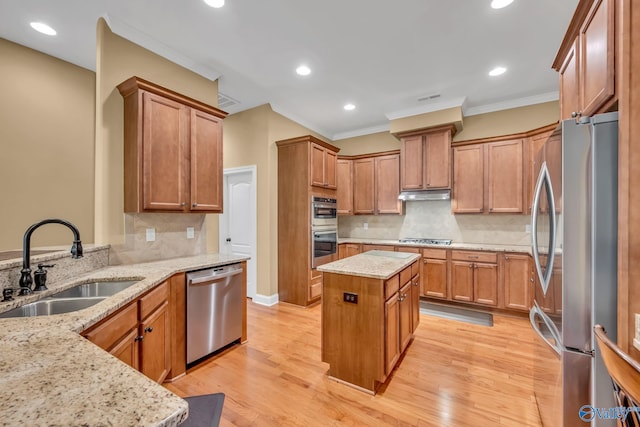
[0,39,95,251]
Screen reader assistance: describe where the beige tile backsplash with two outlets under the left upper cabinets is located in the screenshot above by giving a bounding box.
[109,213,207,265]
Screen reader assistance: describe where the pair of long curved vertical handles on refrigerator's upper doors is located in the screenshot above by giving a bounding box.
[531,162,556,295]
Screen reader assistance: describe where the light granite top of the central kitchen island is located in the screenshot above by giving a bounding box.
[318,251,420,280]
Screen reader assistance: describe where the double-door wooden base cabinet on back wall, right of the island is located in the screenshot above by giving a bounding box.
[451,250,498,307]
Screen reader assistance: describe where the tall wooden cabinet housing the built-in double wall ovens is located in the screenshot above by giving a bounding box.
[276,135,340,306]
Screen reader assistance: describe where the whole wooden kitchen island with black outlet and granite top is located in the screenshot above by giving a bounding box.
[318,251,420,394]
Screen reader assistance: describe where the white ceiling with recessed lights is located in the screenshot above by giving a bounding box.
[0,0,578,140]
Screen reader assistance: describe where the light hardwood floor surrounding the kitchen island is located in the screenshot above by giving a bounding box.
[165,301,540,427]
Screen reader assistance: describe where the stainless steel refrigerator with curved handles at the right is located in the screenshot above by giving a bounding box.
[529,113,618,427]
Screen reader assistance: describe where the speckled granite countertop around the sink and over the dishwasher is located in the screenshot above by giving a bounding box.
[0,254,248,426]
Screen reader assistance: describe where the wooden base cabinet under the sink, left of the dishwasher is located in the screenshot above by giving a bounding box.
[82,281,172,383]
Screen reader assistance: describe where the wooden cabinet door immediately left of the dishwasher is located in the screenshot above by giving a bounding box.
[139,301,171,383]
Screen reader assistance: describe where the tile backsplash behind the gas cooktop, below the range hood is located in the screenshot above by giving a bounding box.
[338,200,531,245]
